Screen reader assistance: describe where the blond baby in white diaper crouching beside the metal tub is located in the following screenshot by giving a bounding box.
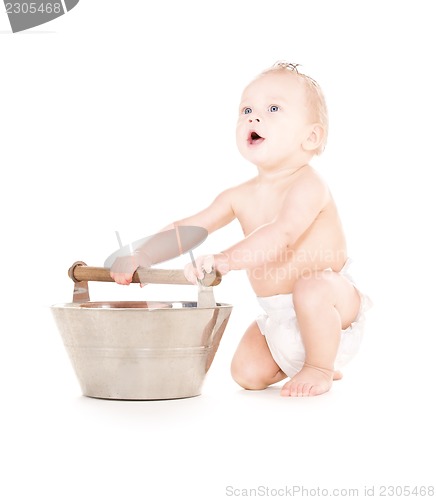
[111,62,366,396]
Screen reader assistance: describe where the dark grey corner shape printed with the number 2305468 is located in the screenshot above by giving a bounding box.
[3,0,79,33]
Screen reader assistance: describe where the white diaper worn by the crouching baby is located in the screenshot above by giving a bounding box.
[257,260,371,377]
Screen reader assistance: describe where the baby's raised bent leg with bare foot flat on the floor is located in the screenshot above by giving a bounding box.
[281,271,360,396]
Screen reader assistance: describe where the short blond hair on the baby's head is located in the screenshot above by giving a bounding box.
[259,61,329,155]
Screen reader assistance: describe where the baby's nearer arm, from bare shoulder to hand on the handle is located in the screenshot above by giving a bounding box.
[185,176,330,281]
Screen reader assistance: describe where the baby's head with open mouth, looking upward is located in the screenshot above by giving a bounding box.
[236,62,328,168]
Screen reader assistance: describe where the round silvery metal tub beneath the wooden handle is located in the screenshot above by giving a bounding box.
[51,264,232,400]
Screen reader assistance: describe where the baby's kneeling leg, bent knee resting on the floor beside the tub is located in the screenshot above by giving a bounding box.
[231,322,286,390]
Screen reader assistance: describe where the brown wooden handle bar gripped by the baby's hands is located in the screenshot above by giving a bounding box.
[68,261,221,286]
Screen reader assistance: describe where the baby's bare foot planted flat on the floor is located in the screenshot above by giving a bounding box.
[280,364,342,397]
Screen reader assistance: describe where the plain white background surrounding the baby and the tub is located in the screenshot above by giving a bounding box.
[0,0,436,500]
